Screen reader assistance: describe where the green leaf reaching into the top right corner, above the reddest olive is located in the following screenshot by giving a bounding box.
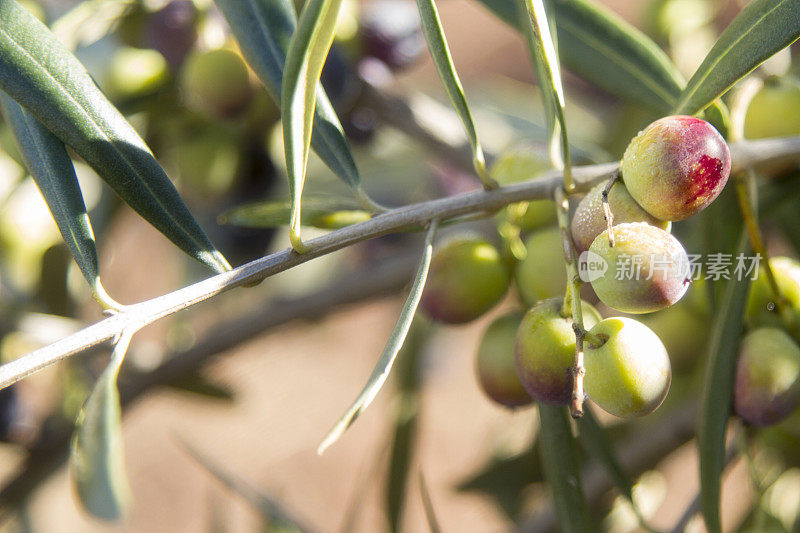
[675,0,800,115]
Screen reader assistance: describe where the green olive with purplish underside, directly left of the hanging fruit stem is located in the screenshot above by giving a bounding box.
[514,298,600,405]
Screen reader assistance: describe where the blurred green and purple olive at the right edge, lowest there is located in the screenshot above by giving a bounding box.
[733,327,800,426]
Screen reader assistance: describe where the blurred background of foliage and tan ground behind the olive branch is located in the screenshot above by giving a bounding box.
[0,0,800,532]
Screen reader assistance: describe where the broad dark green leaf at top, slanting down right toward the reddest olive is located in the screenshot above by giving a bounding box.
[479,0,684,115]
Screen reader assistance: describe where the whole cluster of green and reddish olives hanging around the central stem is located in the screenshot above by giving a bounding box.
[422,116,736,417]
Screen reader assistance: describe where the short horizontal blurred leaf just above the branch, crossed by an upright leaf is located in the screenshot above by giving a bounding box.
[218,195,370,229]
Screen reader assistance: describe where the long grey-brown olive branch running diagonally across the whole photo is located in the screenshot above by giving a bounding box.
[0,137,800,388]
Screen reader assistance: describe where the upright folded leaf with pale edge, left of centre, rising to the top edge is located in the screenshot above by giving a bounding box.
[281,0,342,253]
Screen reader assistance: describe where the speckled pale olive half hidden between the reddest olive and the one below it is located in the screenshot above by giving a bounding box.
[571,181,671,253]
